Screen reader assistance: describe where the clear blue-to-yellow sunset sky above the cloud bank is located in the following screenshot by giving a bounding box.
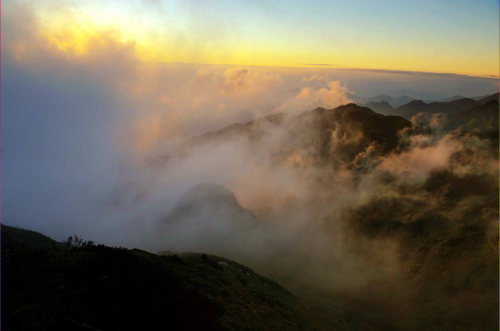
[7,0,499,76]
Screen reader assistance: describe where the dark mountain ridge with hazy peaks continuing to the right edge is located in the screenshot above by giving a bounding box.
[180,93,499,176]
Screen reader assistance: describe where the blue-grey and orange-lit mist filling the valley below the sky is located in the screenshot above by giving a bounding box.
[1,2,498,322]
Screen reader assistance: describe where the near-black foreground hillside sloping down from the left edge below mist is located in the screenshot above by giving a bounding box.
[2,226,312,330]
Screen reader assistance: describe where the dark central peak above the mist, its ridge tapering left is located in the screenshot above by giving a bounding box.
[186,104,411,171]
